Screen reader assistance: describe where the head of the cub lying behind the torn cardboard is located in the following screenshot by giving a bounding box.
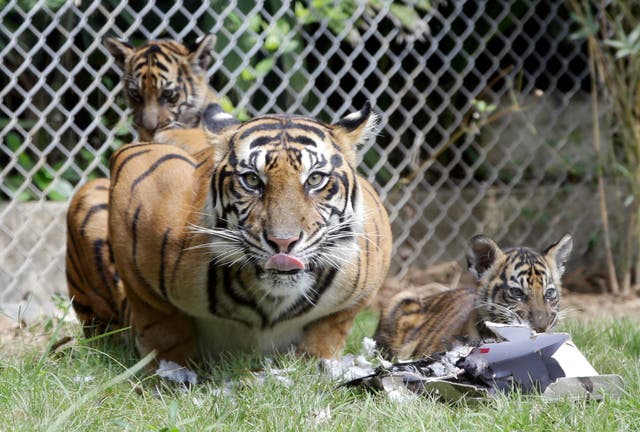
[467,234,573,332]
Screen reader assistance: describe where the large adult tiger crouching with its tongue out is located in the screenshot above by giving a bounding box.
[67,105,391,364]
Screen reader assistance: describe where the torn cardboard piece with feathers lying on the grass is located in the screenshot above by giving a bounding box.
[343,323,624,401]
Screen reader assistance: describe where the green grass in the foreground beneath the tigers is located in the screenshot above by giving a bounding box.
[0,313,640,432]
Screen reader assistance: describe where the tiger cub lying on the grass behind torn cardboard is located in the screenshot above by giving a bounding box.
[374,234,573,359]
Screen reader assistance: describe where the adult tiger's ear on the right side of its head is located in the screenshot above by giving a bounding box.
[332,102,378,166]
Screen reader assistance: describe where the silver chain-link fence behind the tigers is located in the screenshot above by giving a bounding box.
[0,0,599,310]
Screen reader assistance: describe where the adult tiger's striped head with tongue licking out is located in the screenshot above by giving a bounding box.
[203,104,375,294]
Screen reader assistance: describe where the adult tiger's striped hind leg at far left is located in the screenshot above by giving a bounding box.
[66,179,127,335]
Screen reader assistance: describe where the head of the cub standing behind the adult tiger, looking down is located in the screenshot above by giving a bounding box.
[104,34,215,141]
